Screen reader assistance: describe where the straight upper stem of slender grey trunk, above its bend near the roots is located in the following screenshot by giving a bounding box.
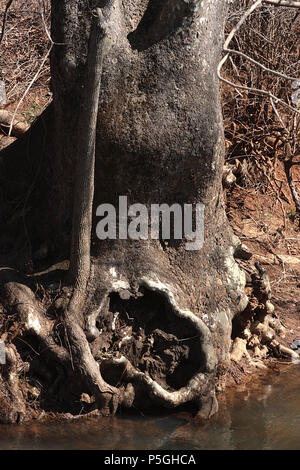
[69,8,110,310]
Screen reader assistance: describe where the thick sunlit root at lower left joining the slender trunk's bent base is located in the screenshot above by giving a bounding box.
[1,270,122,412]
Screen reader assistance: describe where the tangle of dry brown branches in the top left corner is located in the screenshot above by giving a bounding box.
[0,0,51,122]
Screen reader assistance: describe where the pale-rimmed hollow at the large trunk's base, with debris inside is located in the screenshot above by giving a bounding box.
[83,270,217,417]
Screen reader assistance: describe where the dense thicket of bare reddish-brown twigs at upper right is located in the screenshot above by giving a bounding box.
[223,0,300,196]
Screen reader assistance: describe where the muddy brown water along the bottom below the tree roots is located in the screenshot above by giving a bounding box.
[0,365,300,450]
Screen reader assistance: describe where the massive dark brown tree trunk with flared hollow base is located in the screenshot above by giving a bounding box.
[0,0,247,420]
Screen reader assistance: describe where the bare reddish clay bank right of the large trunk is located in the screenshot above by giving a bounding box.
[226,163,300,388]
